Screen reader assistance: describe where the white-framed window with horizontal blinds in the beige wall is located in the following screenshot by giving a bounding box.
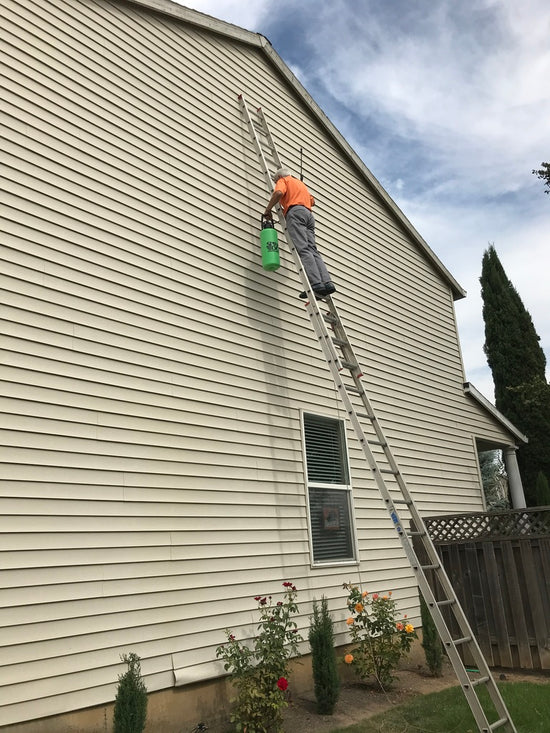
[304,413,355,563]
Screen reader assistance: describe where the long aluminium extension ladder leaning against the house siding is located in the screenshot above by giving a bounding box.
[239,94,517,733]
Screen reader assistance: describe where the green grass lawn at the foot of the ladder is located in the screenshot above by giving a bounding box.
[332,682,550,733]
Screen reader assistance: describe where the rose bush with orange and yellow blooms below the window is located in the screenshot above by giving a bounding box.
[344,583,416,690]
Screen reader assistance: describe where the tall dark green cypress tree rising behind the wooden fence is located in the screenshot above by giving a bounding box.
[480,246,550,506]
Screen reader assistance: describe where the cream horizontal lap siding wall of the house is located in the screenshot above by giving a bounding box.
[0,0,508,725]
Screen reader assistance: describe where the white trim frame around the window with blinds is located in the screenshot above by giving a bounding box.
[300,409,360,569]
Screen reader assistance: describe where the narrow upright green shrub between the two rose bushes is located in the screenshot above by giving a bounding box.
[309,596,340,715]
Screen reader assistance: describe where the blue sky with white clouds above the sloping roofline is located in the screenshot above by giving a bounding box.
[180,0,550,400]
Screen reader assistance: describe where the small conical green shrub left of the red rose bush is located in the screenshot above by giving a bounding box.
[114,652,147,733]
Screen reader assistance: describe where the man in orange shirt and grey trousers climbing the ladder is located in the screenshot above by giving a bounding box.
[263,168,336,299]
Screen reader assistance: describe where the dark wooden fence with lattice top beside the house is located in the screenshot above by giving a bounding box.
[418,507,550,670]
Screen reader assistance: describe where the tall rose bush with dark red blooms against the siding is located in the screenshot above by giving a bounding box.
[216,581,302,733]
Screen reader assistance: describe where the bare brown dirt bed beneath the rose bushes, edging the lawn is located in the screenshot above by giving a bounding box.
[283,663,550,733]
